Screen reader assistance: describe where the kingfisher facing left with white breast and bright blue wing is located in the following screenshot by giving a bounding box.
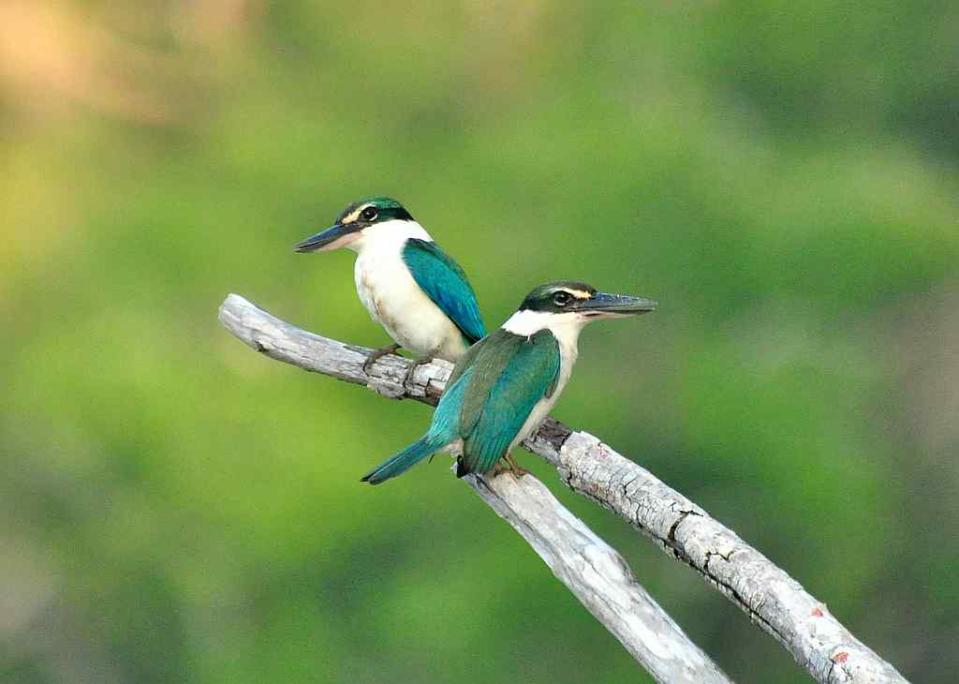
[294,197,486,371]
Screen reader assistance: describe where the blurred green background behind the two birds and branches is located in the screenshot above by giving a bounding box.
[0,0,959,684]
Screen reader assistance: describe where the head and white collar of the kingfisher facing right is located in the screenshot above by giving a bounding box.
[504,280,656,335]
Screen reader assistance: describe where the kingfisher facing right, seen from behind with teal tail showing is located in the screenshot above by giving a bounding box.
[363,280,656,484]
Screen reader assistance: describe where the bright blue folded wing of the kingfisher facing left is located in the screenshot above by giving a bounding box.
[403,238,486,344]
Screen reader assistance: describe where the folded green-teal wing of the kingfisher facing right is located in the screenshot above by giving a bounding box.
[458,330,560,475]
